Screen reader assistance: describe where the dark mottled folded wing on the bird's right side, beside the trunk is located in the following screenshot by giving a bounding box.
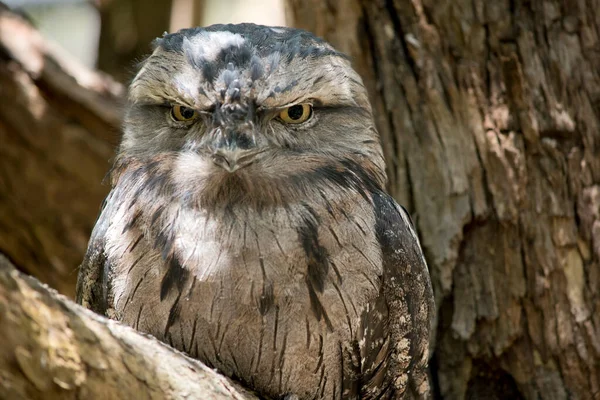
[358,192,435,399]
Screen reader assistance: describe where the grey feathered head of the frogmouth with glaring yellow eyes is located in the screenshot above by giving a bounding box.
[113,24,385,208]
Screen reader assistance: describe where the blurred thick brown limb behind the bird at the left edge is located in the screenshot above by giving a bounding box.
[0,5,123,296]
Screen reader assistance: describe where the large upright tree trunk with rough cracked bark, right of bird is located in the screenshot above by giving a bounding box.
[287,0,600,399]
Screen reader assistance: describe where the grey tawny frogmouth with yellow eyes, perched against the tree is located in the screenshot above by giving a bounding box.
[77,23,435,399]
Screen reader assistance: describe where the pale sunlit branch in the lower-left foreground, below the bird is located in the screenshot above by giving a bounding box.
[0,255,257,400]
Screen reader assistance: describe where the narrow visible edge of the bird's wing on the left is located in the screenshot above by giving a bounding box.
[76,192,114,315]
